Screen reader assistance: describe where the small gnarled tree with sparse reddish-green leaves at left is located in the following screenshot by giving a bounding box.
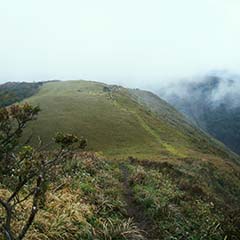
[0,104,86,240]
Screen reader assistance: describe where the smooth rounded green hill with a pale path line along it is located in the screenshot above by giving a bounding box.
[24,81,236,159]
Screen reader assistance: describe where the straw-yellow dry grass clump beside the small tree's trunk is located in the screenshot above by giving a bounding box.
[0,180,94,240]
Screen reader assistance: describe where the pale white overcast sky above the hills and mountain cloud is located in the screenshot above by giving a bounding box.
[0,0,240,88]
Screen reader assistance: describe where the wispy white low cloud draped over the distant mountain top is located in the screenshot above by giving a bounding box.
[158,71,240,109]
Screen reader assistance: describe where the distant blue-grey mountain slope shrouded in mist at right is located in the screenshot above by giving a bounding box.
[160,75,240,154]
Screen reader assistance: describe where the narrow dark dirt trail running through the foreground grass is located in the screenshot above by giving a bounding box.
[120,164,161,240]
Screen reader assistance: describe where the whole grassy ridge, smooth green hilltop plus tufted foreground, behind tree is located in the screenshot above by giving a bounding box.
[0,81,240,240]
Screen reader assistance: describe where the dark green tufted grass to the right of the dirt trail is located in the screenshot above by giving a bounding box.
[124,158,240,240]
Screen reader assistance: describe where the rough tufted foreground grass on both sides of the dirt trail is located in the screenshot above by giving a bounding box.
[0,153,240,240]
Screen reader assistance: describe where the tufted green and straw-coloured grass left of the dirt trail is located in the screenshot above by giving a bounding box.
[0,153,143,240]
